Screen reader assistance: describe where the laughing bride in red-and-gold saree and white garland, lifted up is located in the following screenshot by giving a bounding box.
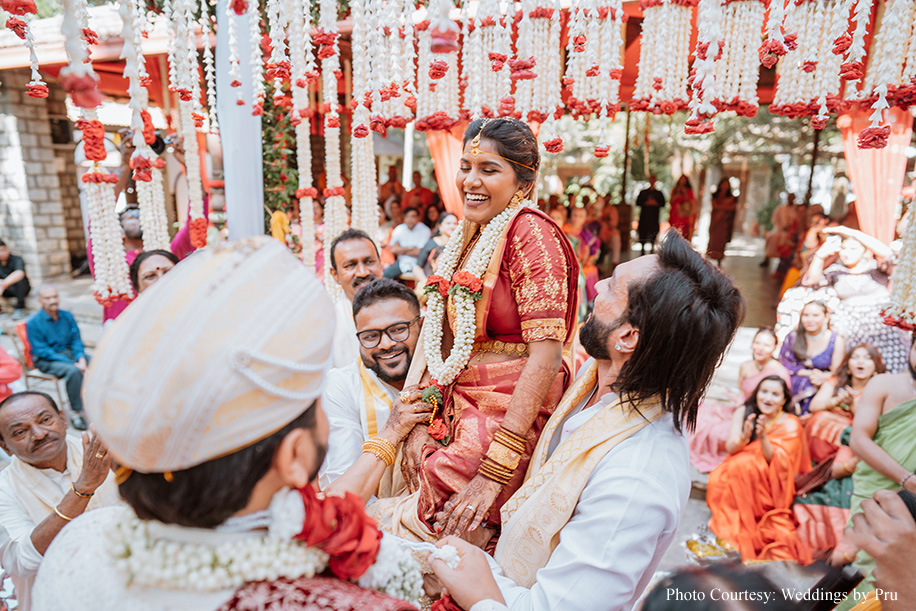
[369,119,579,541]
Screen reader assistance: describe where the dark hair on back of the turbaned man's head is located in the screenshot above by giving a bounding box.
[119,404,321,528]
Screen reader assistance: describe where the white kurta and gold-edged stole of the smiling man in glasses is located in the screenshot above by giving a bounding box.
[318,358,398,489]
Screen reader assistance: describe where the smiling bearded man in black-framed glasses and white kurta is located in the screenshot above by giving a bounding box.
[318,278,431,489]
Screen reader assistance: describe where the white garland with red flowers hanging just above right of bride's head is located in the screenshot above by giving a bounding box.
[509,0,563,153]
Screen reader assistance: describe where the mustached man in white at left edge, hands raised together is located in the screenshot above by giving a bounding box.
[0,391,118,611]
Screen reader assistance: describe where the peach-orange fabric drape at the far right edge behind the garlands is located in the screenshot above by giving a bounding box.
[837,108,913,244]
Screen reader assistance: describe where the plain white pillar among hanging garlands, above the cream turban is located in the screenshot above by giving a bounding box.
[216,0,264,240]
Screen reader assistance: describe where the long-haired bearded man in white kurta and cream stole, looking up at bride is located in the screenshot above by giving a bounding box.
[432,231,745,611]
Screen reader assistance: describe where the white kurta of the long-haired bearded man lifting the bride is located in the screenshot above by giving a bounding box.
[472,395,690,611]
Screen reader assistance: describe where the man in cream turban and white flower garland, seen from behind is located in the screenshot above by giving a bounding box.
[33,237,419,611]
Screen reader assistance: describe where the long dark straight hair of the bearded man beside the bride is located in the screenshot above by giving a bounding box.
[614,230,746,431]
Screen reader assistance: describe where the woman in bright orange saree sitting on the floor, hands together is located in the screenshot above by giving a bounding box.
[706,376,811,564]
